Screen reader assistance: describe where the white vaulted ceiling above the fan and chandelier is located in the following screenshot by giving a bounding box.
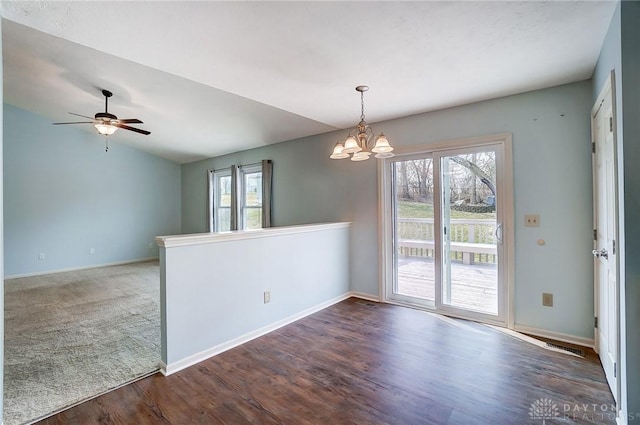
[2,1,616,163]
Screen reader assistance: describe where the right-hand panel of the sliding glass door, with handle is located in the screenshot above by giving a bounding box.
[440,148,501,316]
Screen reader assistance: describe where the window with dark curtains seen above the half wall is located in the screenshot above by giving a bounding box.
[208,160,273,232]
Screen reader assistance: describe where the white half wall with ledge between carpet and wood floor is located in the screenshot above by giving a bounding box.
[156,223,351,375]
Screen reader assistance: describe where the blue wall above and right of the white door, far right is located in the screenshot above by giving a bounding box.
[592,1,640,420]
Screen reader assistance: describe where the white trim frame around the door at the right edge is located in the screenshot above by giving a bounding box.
[591,70,621,408]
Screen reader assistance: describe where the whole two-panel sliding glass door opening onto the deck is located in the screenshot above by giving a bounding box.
[383,137,508,324]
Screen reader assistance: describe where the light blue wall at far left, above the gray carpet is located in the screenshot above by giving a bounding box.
[4,104,181,276]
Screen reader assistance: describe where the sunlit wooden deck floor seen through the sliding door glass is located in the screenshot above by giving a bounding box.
[398,256,498,314]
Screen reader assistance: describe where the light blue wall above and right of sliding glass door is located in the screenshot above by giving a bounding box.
[379,82,593,338]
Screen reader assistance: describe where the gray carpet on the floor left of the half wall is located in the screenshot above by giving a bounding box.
[4,262,160,425]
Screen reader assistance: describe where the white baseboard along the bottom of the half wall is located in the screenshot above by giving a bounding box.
[160,291,358,376]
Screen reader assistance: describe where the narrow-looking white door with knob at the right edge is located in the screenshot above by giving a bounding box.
[591,73,619,400]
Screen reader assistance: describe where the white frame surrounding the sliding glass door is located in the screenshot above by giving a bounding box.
[378,133,515,329]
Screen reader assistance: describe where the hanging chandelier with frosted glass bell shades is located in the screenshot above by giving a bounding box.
[329,86,394,161]
